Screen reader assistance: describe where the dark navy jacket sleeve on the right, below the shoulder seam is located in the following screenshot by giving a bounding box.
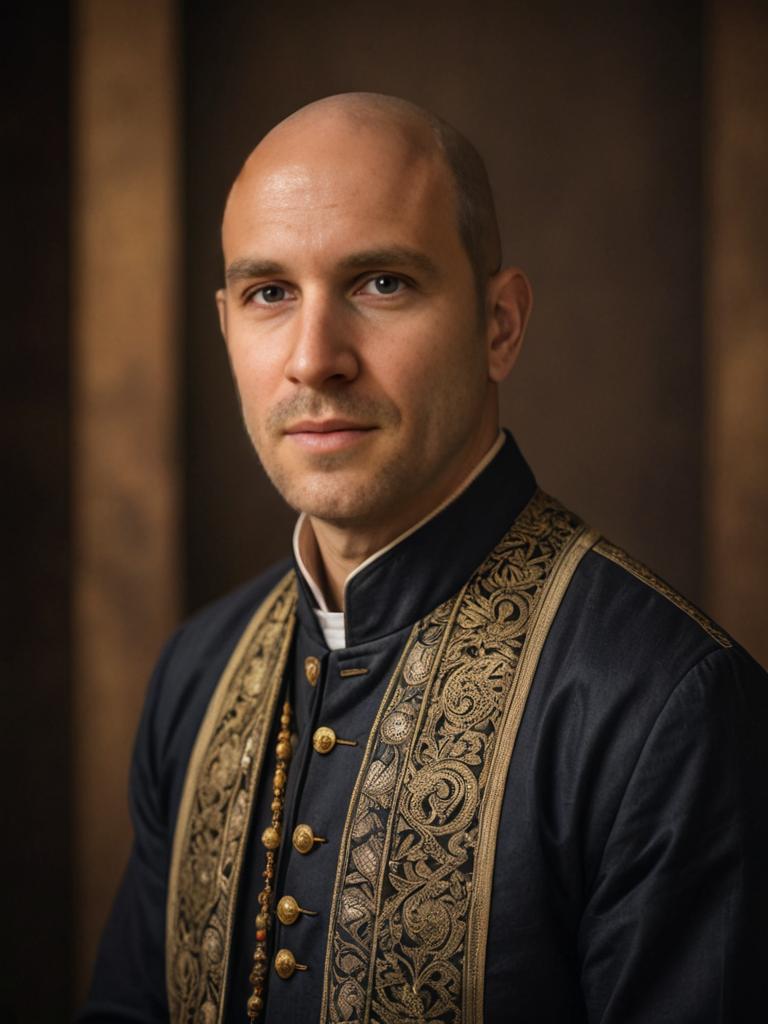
[579,648,768,1024]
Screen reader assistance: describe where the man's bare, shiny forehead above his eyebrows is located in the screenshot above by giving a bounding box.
[223,114,460,261]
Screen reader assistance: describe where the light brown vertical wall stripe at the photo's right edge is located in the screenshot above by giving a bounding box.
[707,0,768,663]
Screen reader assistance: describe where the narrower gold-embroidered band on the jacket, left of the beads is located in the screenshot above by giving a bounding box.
[166,572,297,1024]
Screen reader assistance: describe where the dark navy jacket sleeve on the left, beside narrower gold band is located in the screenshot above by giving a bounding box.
[76,634,185,1024]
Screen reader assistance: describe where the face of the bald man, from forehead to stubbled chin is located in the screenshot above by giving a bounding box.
[218,118,498,539]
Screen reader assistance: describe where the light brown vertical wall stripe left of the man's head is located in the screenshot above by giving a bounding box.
[73,0,178,990]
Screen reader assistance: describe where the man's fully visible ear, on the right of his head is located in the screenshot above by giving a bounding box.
[486,266,534,383]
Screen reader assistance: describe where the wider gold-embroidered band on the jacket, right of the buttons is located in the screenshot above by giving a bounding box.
[321,493,596,1024]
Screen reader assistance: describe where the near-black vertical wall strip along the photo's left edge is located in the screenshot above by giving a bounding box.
[0,4,72,1024]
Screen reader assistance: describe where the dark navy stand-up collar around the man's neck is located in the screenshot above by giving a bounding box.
[295,431,536,647]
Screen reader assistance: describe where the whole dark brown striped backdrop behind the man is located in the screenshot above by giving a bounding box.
[0,0,768,1022]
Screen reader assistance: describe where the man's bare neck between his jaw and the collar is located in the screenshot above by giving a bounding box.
[299,433,503,611]
